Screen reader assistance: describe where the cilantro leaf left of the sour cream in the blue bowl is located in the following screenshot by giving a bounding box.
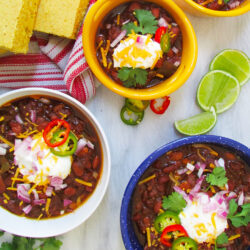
[162,192,187,213]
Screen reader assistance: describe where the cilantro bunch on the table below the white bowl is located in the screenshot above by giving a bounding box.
[0,236,62,250]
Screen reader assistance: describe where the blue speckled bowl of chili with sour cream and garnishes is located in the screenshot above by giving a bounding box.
[120,135,250,250]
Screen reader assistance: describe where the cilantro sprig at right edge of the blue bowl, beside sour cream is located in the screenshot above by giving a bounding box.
[227,199,250,227]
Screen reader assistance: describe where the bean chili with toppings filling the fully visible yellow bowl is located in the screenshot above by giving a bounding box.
[96,1,182,88]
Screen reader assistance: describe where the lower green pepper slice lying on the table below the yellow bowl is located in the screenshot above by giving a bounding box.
[120,106,144,126]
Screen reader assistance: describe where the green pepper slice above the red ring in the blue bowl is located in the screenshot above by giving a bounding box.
[154,211,180,233]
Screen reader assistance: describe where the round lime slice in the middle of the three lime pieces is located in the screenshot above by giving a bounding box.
[197,70,240,114]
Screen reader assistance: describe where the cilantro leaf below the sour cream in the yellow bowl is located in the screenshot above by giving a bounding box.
[118,67,148,87]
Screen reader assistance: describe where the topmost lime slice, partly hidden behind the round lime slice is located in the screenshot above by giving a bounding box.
[209,49,250,86]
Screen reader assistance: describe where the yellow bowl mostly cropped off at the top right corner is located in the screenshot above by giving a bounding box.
[174,0,250,17]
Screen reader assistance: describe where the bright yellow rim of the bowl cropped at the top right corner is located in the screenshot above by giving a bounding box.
[183,0,250,17]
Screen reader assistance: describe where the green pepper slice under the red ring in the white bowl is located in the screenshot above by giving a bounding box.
[50,131,78,156]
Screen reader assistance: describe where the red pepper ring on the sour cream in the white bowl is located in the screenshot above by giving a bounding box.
[43,119,70,148]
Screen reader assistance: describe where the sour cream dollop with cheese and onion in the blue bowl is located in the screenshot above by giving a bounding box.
[179,193,228,243]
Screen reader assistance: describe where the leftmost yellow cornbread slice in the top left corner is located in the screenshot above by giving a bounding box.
[0,0,39,53]
